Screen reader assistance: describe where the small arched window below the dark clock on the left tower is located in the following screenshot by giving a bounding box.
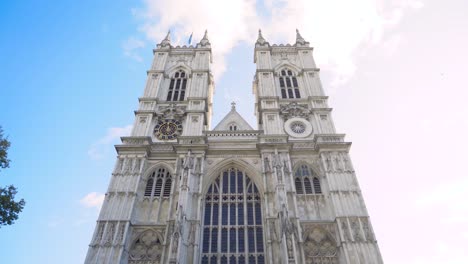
[145,168,172,197]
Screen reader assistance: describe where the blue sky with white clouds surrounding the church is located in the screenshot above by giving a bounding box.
[0,0,468,264]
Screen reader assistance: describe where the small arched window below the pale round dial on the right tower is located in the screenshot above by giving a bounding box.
[294,164,322,194]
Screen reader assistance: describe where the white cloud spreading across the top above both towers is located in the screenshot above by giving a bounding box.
[132,0,423,85]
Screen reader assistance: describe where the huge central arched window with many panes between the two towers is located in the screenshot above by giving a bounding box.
[201,168,265,264]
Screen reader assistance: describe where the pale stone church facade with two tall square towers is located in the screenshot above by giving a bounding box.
[85,29,383,264]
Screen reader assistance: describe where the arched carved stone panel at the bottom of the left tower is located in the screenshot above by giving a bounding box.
[128,229,163,264]
